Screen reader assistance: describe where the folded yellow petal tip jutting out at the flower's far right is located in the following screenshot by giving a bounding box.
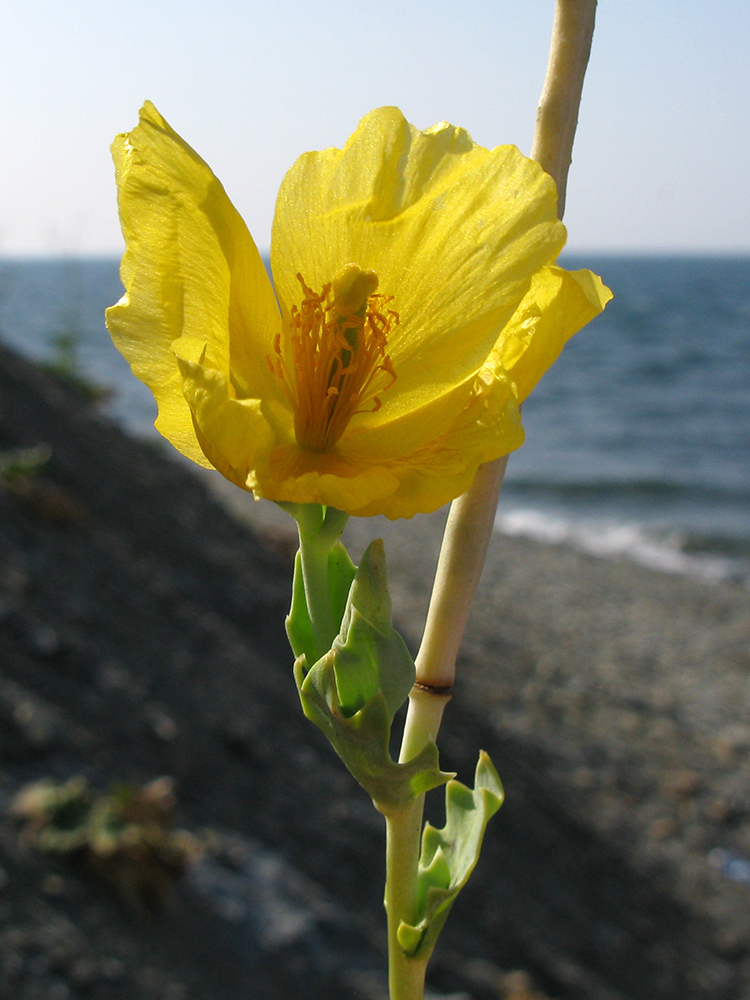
[492,267,612,402]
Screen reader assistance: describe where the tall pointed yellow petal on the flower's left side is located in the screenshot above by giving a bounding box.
[107,103,279,465]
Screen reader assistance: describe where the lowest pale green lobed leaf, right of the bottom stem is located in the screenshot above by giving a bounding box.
[398,750,505,959]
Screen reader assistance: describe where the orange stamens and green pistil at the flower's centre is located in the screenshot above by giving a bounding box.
[267,264,398,452]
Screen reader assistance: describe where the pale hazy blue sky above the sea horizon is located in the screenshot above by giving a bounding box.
[0,0,750,257]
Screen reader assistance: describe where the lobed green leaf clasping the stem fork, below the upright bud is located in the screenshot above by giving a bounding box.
[294,650,453,813]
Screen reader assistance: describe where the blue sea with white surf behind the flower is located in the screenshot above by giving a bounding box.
[0,254,750,586]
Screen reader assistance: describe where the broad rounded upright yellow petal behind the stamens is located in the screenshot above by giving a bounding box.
[271,108,565,426]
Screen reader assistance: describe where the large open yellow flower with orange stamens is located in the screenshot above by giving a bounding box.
[107,103,611,518]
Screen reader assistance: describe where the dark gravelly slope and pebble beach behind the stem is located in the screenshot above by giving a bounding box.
[0,340,750,1000]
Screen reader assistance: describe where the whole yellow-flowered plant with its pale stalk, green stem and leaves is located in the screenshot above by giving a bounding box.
[107,0,610,1000]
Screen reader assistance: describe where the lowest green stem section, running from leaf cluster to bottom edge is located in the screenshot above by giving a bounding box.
[385,796,427,1000]
